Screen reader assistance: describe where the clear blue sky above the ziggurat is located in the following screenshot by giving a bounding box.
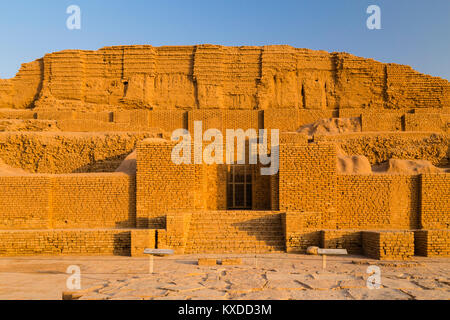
[0,0,450,79]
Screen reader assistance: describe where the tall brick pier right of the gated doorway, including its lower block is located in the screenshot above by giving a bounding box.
[278,140,337,252]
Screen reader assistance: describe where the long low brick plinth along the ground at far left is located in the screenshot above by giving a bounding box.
[0,229,131,256]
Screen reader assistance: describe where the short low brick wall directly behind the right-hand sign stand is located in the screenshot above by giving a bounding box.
[320,230,363,254]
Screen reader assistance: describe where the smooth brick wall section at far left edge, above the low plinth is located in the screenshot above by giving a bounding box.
[0,175,51,229]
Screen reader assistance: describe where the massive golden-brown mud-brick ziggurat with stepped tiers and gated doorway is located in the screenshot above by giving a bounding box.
[0,45,450,259]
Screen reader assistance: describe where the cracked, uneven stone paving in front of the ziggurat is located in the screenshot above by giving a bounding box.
[0,254,450,300]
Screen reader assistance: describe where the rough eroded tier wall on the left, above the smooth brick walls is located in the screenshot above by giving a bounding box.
[0,131,159,173]
